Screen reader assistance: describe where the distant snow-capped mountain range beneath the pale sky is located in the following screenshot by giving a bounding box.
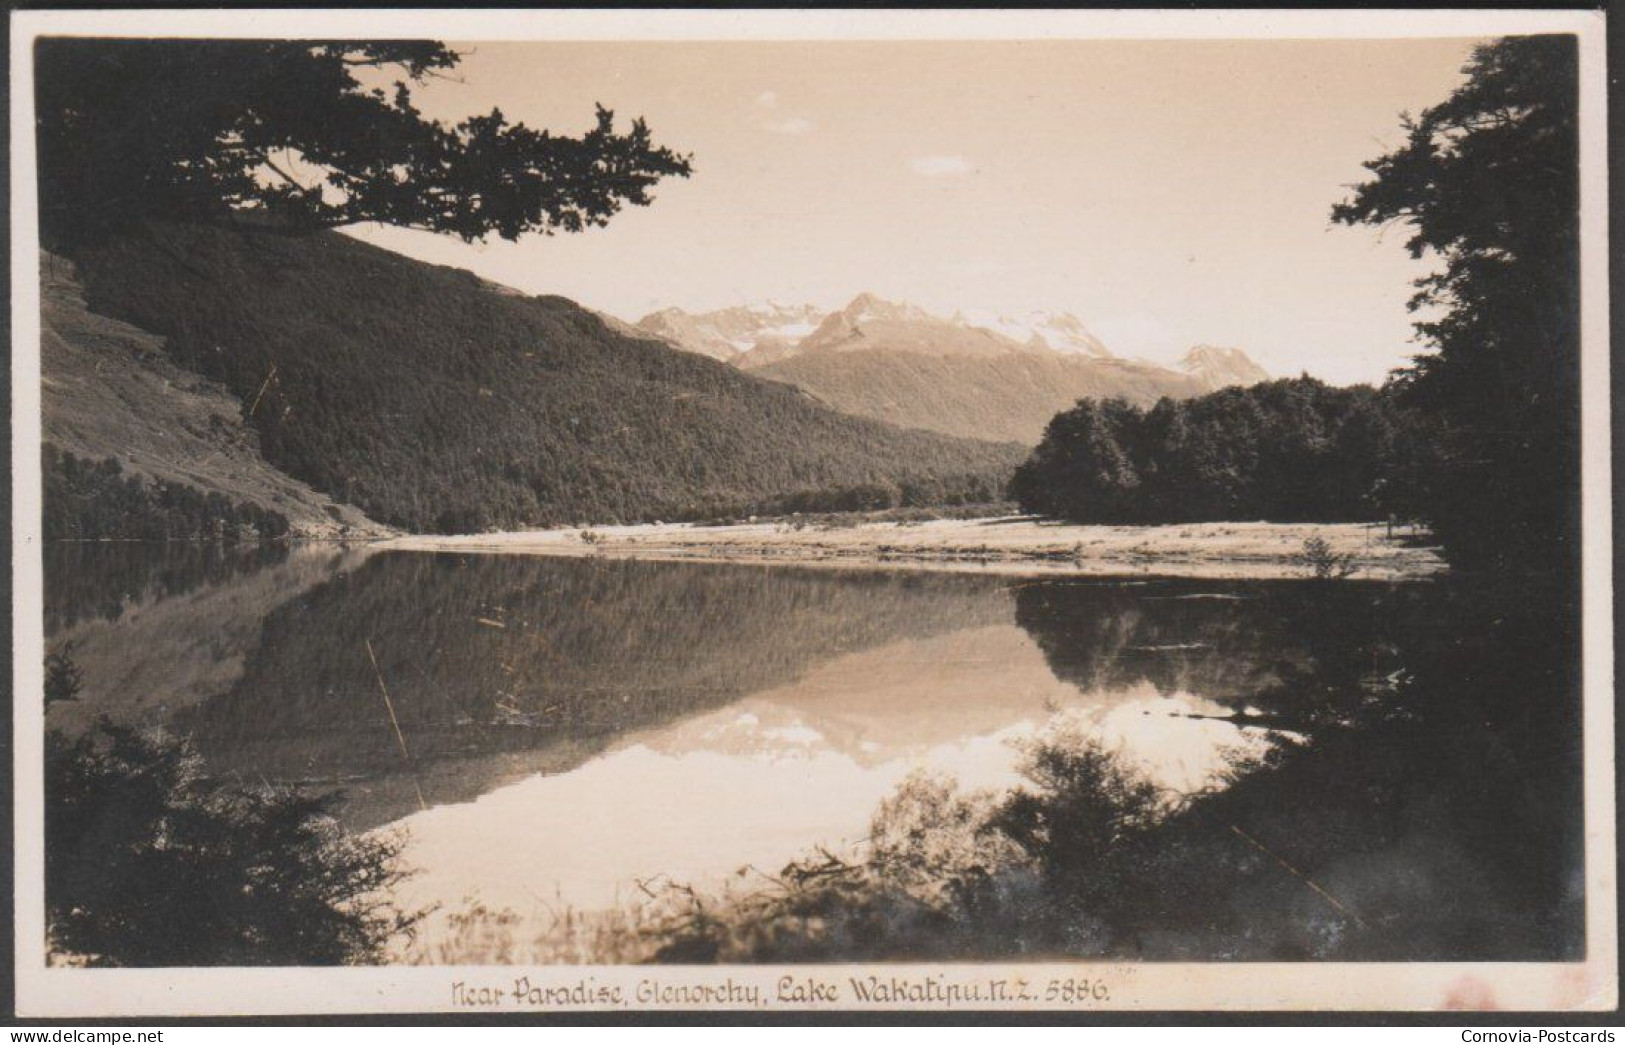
[635,293,1269,445]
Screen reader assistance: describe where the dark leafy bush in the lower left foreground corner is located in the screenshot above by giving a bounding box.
[46,722,421,965]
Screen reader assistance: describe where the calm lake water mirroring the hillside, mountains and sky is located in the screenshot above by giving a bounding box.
[46,544,1579,962]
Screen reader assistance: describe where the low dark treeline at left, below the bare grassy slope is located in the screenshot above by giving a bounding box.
[41,444,288,541]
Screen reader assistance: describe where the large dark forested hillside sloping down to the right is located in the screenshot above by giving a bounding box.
[73,223,1021,531]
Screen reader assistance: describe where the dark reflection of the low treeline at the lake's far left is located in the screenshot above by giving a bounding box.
[44,541,288,635]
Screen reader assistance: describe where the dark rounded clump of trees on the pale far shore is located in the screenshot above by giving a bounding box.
[1011,377,1427,523]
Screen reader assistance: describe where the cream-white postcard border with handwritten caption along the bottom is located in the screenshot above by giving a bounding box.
[10,10,1619,1017]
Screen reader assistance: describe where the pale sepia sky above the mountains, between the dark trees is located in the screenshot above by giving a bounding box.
[353,39,1472,382]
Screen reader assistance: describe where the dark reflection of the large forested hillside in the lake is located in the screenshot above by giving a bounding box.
[185,554,1011,813]
